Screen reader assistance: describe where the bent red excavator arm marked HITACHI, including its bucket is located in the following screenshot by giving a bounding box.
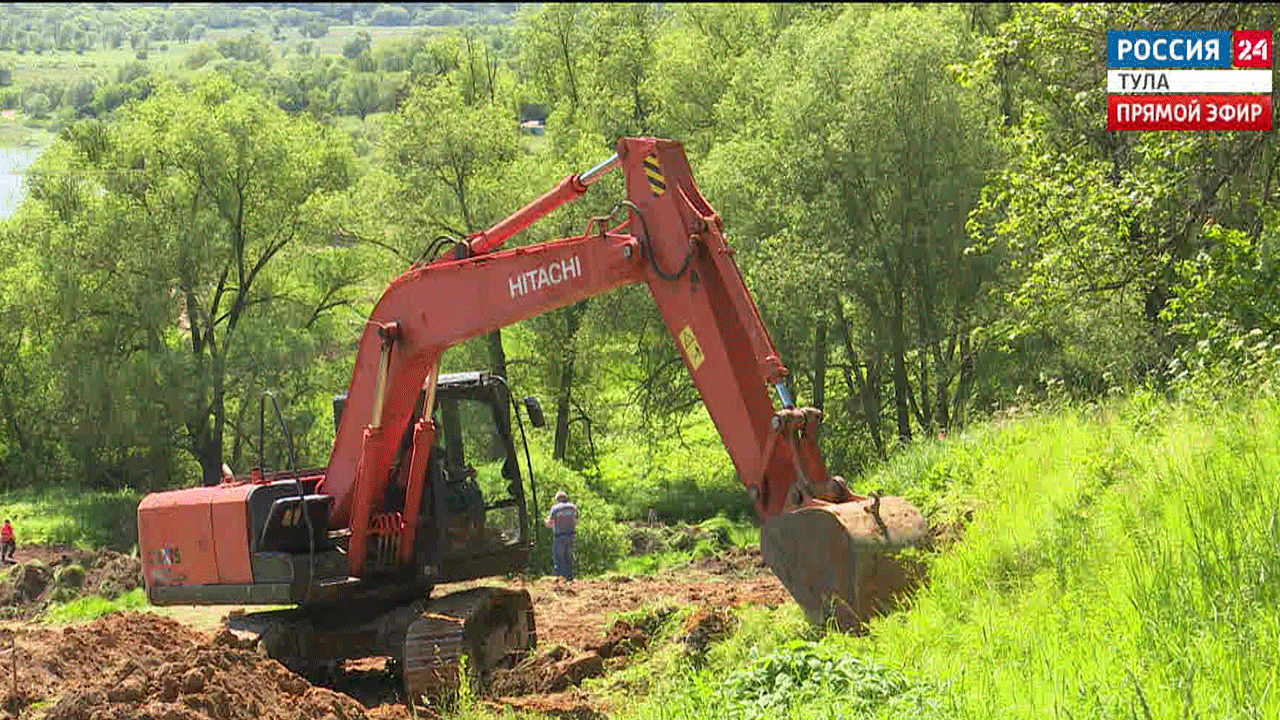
[316,137,925,625]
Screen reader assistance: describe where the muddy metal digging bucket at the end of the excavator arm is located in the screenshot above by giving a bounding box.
[760,497,929,632]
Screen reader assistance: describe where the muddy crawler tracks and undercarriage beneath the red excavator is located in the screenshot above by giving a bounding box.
[227,587,538,706]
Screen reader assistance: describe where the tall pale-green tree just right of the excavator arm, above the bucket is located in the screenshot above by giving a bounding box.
[704,6,995,465]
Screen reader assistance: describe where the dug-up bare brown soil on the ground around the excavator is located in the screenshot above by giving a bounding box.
[0,530,942,720]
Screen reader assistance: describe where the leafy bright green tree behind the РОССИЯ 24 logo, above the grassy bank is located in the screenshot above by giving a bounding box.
[970,3,1276,392]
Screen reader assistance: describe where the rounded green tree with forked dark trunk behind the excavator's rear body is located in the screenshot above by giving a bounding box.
[28,77,353,483]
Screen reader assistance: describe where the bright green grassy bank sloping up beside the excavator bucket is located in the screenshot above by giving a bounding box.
[599,395,1280,719]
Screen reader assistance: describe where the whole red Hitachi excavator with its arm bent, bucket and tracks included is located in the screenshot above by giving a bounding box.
[138,137,927,698]
